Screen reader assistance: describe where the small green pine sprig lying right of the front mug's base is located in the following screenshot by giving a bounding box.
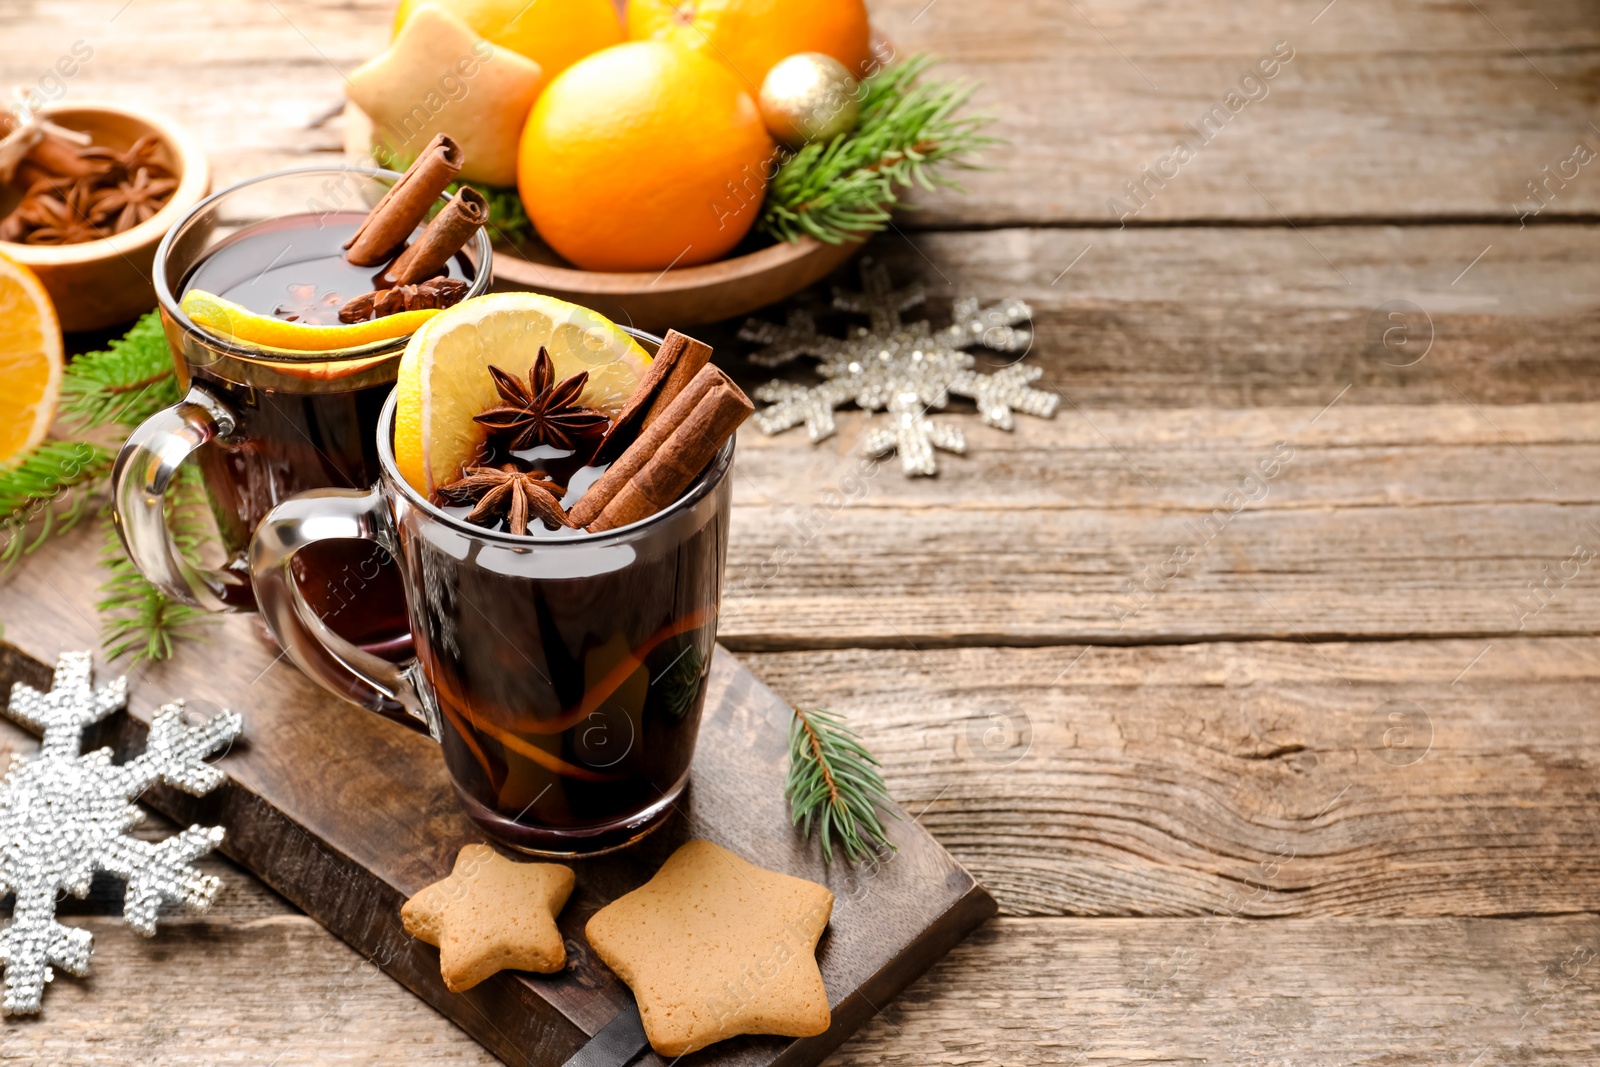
[784,707,899,864]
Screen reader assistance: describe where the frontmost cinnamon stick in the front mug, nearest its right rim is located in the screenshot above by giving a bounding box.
[570,365,755,533]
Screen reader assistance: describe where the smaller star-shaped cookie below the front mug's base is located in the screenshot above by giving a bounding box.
[400,845,573,993]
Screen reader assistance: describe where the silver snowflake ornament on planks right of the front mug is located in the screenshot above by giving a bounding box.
[739,259,1059,474]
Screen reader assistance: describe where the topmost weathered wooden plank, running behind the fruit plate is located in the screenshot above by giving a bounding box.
[0,0,1600,220]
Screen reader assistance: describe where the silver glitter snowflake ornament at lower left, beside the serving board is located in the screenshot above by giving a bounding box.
[0,653,243,1014]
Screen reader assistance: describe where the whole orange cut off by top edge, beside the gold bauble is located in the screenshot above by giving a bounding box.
[627,0,870,87]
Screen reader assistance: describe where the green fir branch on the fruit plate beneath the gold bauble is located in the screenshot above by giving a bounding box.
[757,56,1000,245]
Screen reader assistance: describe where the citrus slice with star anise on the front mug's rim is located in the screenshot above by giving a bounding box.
[394,293,650,496]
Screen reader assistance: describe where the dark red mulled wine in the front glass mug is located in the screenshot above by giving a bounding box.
[397,428,731,853]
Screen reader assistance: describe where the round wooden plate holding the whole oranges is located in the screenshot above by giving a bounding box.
[344,104,862,333]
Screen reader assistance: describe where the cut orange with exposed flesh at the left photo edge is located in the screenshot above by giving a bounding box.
[0,254,64,464]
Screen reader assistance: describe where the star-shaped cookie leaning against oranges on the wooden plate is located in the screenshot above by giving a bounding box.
[346,5,544,186]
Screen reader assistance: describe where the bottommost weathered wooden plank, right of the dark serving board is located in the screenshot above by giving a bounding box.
[837,915,1600,1067]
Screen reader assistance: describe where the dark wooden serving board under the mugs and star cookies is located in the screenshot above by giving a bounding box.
[0,639,995,1067]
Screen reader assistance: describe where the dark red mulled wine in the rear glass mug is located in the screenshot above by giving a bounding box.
[174,211,474,654]
